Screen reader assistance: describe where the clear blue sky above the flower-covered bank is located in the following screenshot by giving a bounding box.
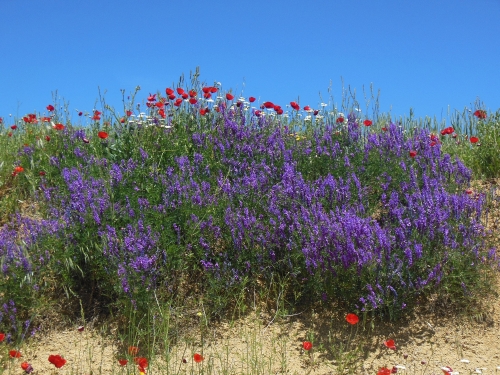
[0,0,500,123]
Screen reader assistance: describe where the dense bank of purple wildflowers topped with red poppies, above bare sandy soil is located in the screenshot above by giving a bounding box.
[0,85,498,339]
